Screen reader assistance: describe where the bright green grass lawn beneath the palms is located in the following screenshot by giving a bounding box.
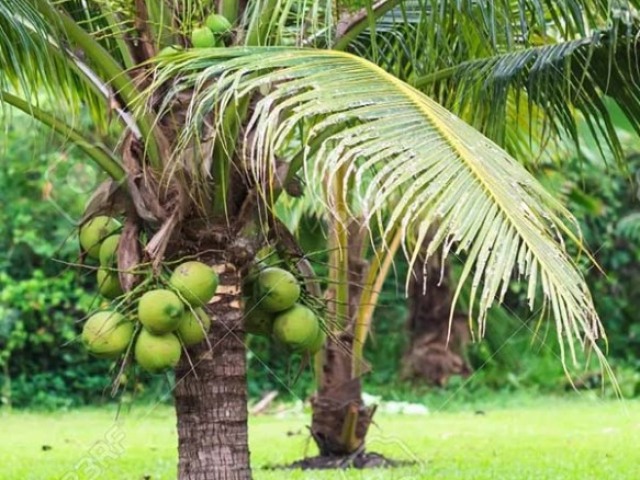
[0,399,640,480]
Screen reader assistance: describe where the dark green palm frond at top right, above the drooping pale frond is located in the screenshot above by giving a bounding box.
[351,0,640,160]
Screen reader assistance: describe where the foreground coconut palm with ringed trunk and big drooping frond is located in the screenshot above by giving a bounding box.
[0,0,635,479]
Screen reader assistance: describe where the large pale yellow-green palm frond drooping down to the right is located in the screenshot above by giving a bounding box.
[152,48,603,359]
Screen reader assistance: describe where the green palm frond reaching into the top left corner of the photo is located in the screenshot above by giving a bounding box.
[0,0,161,165]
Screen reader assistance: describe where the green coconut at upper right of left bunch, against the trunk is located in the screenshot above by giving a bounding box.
[169,261,218,307]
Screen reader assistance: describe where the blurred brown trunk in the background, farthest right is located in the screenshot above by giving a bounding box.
[402,248,471,386]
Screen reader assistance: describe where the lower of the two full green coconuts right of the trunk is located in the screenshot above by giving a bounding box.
[273,304,320,351]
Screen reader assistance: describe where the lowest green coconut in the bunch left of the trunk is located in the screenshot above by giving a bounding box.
[134,328,182,373]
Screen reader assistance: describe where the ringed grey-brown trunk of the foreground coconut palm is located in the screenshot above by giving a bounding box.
[175,264,251,480]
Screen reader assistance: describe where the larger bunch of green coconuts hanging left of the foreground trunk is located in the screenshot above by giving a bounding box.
[79,216,218,373]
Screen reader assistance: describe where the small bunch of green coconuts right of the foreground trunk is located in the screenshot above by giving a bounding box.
[243,267,326,355]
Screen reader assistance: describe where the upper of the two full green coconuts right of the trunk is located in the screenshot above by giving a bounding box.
[255,267,300,312]
